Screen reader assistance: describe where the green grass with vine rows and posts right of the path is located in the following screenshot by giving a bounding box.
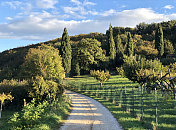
[67,75,176,130]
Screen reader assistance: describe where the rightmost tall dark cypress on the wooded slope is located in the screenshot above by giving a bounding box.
[155,24,164,56]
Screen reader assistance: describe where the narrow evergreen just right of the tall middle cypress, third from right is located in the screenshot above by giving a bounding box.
[116,35,124,66]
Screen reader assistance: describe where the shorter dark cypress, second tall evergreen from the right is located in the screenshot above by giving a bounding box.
[126,32,134,56]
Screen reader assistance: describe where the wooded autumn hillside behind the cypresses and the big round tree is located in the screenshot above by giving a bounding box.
[0,20,176,81]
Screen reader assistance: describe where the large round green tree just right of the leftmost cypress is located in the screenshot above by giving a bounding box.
[76,38,105,71]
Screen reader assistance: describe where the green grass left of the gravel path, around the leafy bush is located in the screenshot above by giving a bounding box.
[0,98,71,130]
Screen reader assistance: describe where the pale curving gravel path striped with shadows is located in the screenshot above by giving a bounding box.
[60,90,122,130]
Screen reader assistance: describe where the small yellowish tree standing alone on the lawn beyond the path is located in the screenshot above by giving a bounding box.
[90,70,111,87]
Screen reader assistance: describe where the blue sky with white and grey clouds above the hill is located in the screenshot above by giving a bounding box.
[0,0,176,52]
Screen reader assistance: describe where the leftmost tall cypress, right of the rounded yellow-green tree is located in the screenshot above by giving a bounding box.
[61,28,72,73]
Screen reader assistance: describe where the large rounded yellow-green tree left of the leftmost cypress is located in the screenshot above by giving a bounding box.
[20,45,64,81]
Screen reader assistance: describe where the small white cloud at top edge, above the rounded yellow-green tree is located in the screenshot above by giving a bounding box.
[36,0,58,9]
